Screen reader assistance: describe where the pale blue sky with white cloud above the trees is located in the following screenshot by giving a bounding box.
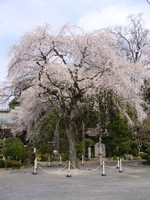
[0,0,150,82]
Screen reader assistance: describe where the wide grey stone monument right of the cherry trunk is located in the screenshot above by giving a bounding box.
[95,136,106,158]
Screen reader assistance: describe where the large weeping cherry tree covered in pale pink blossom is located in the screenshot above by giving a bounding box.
[4,25,149,165]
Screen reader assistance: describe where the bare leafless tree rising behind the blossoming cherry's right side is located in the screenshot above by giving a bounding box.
[111,14,149,63]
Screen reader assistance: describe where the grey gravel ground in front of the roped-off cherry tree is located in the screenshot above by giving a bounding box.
[0,161,150,200]
